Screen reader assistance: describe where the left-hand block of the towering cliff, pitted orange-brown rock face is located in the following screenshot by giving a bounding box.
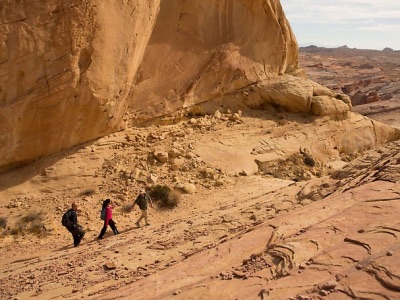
[0,0,159,170]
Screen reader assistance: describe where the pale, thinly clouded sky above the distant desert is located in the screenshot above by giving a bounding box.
[281,0,400,50]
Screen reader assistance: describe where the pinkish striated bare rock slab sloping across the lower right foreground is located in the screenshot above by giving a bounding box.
[94,142,400,299]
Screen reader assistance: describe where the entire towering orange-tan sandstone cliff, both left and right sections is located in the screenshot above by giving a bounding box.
[0,0,298,170]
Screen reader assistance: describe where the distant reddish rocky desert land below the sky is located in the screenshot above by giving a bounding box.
[299,46,400,106]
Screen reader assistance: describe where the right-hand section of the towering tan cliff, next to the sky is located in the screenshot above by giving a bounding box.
[131,0,298,121]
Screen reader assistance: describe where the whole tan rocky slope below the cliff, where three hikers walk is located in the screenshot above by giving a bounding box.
[0,110,400,299]
